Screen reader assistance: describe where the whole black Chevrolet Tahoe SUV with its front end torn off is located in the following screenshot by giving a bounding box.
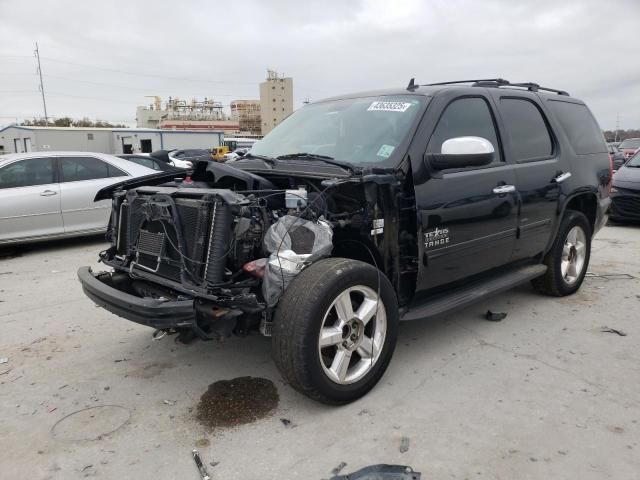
[78,79,611,404]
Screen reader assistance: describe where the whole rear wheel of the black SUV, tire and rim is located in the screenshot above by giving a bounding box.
[532,210,591,297]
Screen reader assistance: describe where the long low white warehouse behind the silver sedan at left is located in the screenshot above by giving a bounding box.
[0,125,224,154]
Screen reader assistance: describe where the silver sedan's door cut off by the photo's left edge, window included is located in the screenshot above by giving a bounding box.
[0,157,64,242]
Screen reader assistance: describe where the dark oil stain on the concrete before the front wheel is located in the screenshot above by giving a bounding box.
[196,377,279,430]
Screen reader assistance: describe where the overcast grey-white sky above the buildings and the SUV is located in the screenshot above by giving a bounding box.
[0,0,640,129]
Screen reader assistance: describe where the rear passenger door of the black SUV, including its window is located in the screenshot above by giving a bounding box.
[491,89,570,260]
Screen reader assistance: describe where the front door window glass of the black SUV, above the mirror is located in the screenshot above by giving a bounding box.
[427,97,502,162]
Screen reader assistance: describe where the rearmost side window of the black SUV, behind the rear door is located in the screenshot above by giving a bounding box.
[549,100,607,155]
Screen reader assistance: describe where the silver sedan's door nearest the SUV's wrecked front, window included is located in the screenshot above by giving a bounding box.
[59,155,128,233]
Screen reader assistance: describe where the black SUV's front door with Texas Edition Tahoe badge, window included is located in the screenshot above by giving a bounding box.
[415,93,517,291]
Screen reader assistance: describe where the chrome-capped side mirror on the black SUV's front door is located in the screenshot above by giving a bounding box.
[427,137,495,170]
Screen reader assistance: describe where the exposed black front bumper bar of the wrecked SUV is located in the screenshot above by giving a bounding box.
[78,267,195,330]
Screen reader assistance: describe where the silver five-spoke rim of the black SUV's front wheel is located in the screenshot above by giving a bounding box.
[318,285,387,385]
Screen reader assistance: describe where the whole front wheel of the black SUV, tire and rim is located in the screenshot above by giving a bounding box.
[272,258,398,405]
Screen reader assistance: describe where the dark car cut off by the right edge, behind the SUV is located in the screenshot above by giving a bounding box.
[609,151,640,222]
